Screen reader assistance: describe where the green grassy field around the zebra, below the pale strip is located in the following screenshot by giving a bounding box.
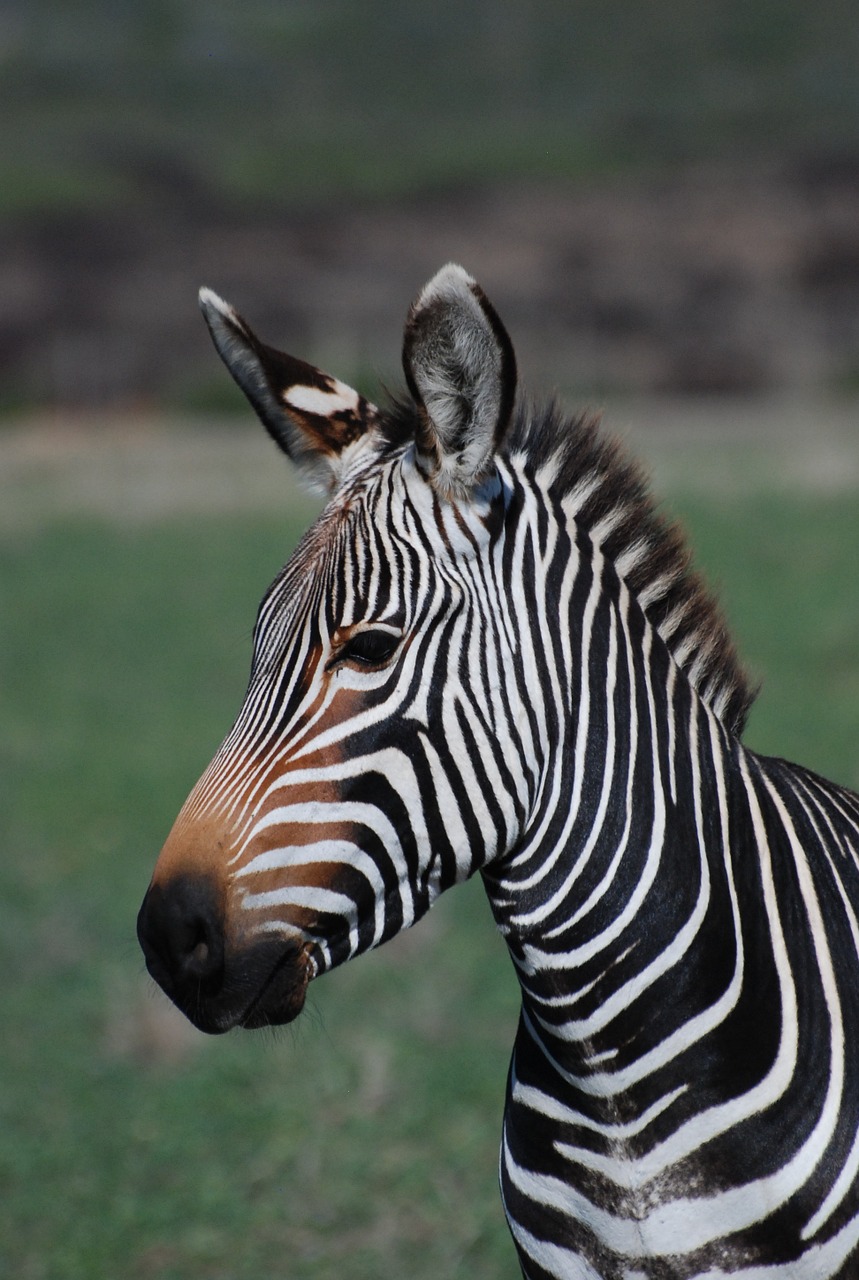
[0,432,859,1280]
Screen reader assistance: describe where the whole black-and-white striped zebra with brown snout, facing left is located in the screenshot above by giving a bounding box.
[138,264,859,1280]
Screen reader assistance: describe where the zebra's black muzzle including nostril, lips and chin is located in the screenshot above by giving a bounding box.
[137,876,316,1036]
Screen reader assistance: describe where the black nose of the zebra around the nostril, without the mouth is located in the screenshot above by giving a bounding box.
[137,876,224,1012]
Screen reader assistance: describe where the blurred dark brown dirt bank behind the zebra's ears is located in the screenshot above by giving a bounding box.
[0,157,859,407]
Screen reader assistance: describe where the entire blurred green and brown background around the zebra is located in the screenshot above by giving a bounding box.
[0,0,859,1280]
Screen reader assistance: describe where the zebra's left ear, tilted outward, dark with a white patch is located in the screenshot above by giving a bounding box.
[200,289,379,493]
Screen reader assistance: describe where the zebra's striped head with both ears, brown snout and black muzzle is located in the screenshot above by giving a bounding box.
[138,265,527,1032]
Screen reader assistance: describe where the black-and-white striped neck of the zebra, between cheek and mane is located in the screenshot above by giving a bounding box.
[484,455,743,1094]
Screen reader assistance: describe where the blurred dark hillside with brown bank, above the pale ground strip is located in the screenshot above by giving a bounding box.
[0,0,859,408]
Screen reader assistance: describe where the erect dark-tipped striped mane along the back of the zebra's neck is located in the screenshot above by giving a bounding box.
[504,403,754,735]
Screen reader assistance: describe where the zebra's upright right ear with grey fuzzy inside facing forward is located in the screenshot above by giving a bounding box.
[403,262,516,497]
